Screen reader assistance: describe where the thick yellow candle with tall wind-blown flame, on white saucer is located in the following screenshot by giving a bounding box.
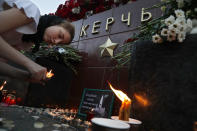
[108,83,131,121]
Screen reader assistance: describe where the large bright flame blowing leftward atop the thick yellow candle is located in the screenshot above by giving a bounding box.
[108,82,131,102]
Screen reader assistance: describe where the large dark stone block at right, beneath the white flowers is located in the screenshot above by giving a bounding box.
[130,35,197,131]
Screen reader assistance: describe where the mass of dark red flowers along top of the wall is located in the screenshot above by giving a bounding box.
[51,0,136,21]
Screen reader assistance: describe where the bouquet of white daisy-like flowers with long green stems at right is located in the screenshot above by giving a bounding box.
[113,0,197,67]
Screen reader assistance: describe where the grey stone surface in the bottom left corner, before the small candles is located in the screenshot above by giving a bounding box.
[0,106,78,131]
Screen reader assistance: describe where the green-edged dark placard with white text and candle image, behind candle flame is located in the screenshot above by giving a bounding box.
[78,88,114,118]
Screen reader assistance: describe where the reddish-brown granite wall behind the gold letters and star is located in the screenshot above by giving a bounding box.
[68,0,161,115]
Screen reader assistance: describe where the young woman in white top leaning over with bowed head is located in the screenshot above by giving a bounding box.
[0,0,74,82]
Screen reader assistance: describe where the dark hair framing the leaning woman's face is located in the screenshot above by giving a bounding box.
[22,15,75,52]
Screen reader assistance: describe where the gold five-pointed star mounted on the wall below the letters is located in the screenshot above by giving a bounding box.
[99,37,118,57]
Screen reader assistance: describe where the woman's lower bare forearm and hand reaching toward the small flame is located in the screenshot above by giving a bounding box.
[0,36,47,81]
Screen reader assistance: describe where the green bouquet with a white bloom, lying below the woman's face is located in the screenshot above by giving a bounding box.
[22,43,81,74]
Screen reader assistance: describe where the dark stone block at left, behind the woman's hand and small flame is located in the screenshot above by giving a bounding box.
[25,58,74,108]
